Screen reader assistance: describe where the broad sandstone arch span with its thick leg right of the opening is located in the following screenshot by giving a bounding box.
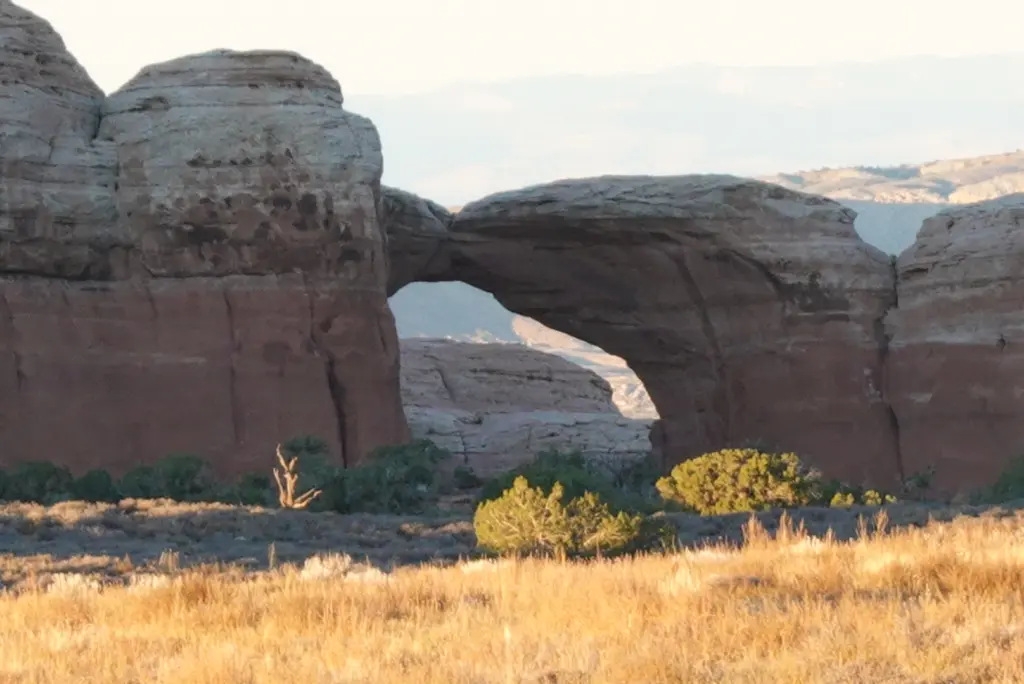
[392,176,900,487]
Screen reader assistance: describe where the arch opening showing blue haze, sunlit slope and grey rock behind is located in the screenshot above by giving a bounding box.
[389,282,657,476]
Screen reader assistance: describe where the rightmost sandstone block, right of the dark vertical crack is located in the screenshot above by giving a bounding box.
[886,195,1024,491]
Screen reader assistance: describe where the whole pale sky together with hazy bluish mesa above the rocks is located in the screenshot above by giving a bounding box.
[17,0,1024,205]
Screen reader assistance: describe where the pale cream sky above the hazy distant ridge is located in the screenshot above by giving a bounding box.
[16,0,1024,94]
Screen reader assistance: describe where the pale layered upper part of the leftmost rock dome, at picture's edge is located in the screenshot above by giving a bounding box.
[0,0,120,277]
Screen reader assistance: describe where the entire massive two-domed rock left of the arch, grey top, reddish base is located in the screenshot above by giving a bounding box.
[0,1,409,476]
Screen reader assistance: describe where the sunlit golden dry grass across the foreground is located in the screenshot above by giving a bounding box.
[6,515,1024,684]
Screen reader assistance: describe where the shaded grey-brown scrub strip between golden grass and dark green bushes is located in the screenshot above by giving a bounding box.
[0,500,1024,586]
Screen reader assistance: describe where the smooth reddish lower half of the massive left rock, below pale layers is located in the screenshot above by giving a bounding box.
[0,276,408,477]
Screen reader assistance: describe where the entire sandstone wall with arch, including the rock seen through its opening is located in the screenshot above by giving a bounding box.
[16,0,1024,497]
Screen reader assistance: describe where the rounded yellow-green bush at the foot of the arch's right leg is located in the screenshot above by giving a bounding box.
[657,448,821,515]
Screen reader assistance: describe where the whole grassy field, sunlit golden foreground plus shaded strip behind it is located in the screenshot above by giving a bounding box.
[0,502,1024,684]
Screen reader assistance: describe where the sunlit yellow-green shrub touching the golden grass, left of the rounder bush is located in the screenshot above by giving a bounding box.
[473,475,644,556]
